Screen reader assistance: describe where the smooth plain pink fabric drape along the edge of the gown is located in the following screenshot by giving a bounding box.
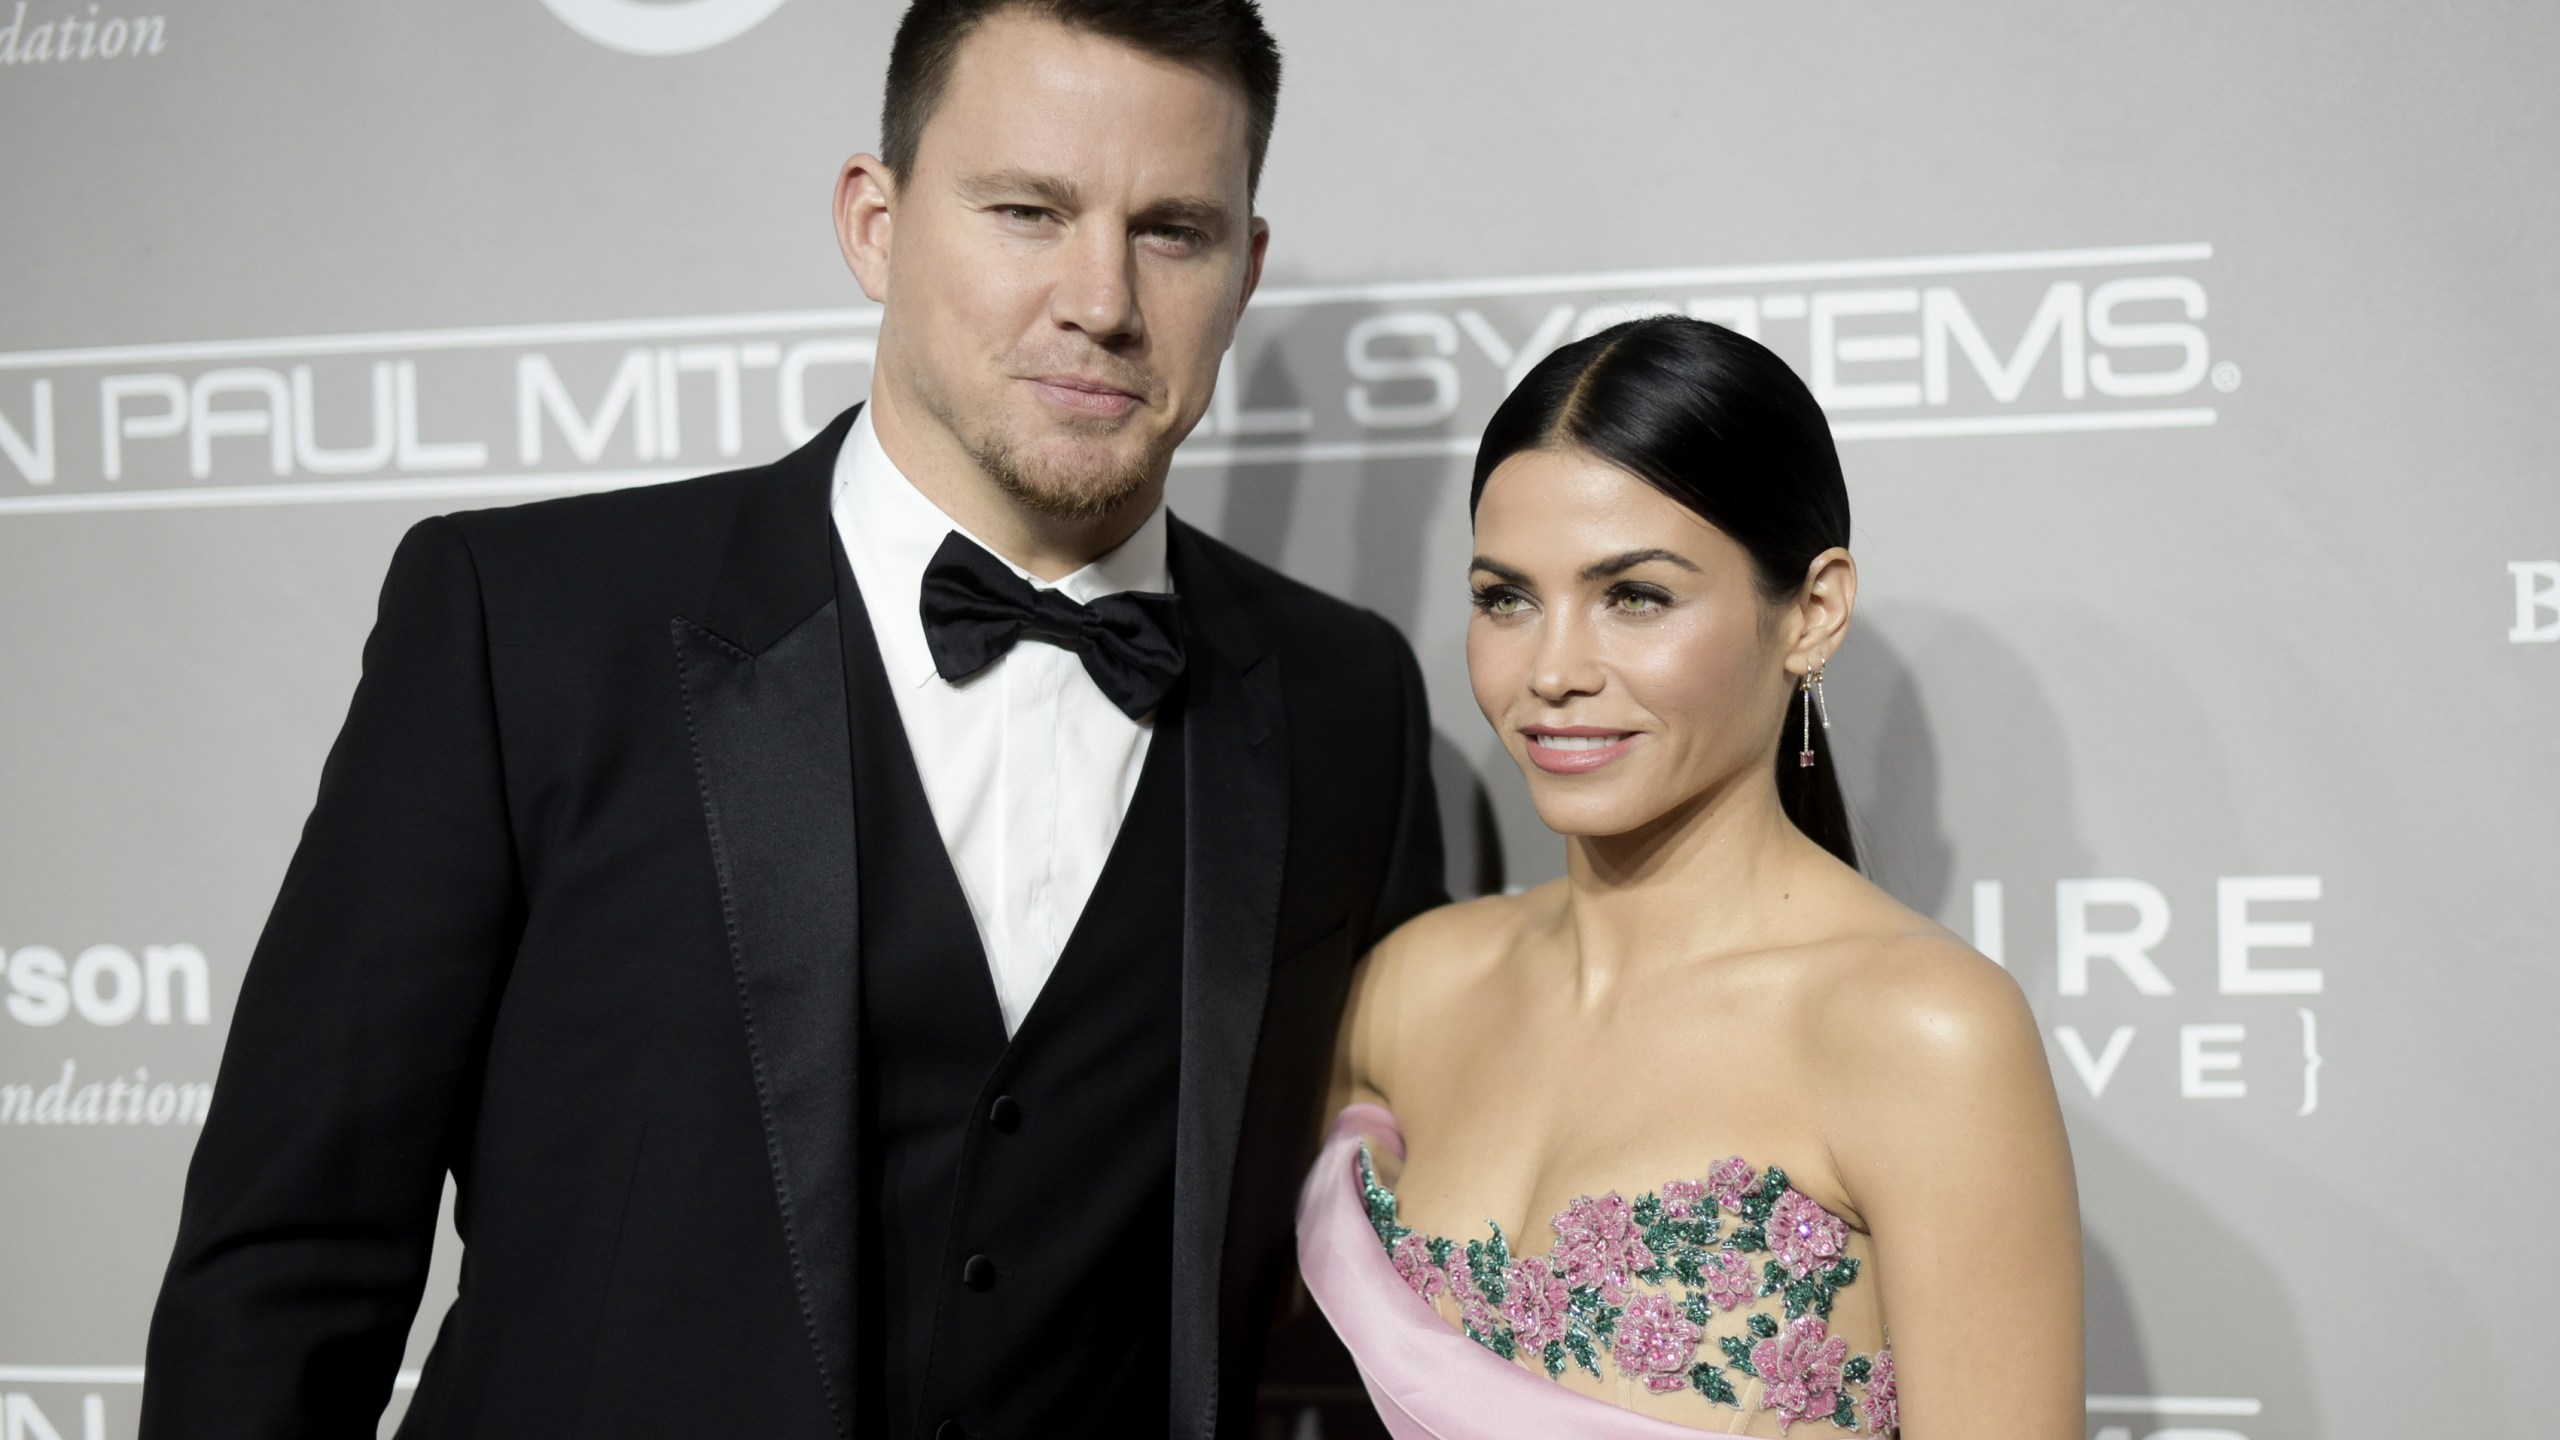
[1298,1104,1736,1440]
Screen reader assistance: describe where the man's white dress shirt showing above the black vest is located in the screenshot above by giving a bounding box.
[835,405,1172,1035]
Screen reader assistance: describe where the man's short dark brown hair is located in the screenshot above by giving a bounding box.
[881,0,1280,195]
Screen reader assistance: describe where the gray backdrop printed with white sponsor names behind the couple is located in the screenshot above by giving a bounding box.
[0,0,2560,1440]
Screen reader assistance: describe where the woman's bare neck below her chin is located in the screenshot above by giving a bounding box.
[1564,771,1810,1002]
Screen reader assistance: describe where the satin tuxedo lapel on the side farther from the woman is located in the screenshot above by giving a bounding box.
[671,410,860,1435]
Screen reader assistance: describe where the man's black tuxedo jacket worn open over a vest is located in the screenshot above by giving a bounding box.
[141,413,1441,1440]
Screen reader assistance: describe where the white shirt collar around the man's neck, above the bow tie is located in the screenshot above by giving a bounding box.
[832,405,1172,689]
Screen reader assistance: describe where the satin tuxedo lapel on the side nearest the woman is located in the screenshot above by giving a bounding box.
[1170,520,1288,1440]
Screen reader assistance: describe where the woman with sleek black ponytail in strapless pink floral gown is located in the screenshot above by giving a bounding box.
[1298,315,2081,1440]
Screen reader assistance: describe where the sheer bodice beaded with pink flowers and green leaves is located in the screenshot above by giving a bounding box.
[1359,1145,1900,1435]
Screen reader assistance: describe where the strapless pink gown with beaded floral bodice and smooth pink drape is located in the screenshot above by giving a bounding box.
[1298,1104,1900,1440]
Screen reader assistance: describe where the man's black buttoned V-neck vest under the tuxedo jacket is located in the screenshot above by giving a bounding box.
[837,551,1183,1440]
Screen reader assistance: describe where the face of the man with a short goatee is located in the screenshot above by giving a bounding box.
[858,15,1265,518]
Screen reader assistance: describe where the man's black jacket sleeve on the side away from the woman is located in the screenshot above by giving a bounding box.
[141,520,522,1440]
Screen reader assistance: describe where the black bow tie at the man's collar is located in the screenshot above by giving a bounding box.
[922,530,1183,720]
